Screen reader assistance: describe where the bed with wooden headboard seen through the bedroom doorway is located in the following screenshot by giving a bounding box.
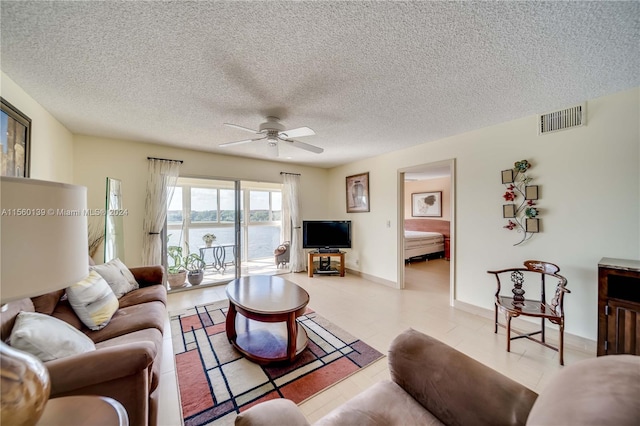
[404,219,451,260]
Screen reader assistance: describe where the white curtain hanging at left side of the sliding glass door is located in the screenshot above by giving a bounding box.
[142,158,181,265]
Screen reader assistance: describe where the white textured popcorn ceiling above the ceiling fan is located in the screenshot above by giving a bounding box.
[0,1,640,167]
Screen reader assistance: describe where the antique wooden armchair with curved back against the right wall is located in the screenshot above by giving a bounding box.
[487,260,570,365]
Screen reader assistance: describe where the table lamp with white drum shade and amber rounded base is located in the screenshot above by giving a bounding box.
[0,176,89,425]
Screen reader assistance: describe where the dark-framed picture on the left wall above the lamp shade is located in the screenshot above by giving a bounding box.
[0,97,31,177]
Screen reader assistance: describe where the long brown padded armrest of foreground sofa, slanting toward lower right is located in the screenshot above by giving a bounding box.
[389,329,537,425]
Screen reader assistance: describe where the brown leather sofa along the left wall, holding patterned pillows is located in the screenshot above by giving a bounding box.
[1,266,167,426]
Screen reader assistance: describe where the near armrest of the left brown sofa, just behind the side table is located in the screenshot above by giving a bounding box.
[45,342,156,396]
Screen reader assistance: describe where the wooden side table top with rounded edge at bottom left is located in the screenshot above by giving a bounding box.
[36,395,129,426]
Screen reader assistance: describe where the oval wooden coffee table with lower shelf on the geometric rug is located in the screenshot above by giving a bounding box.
[226,275,309,364]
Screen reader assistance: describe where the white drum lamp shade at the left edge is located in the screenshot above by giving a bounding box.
[0,176,89,304]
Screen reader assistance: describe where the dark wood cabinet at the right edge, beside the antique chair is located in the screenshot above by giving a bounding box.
[598,257,640,356]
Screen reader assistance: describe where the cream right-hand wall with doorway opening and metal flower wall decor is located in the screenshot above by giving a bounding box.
[329,88,640,340]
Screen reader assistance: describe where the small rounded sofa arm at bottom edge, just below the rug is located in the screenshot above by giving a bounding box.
[235,398,309,426]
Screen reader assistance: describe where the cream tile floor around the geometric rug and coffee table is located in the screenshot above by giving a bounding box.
[159,259,595,426]
